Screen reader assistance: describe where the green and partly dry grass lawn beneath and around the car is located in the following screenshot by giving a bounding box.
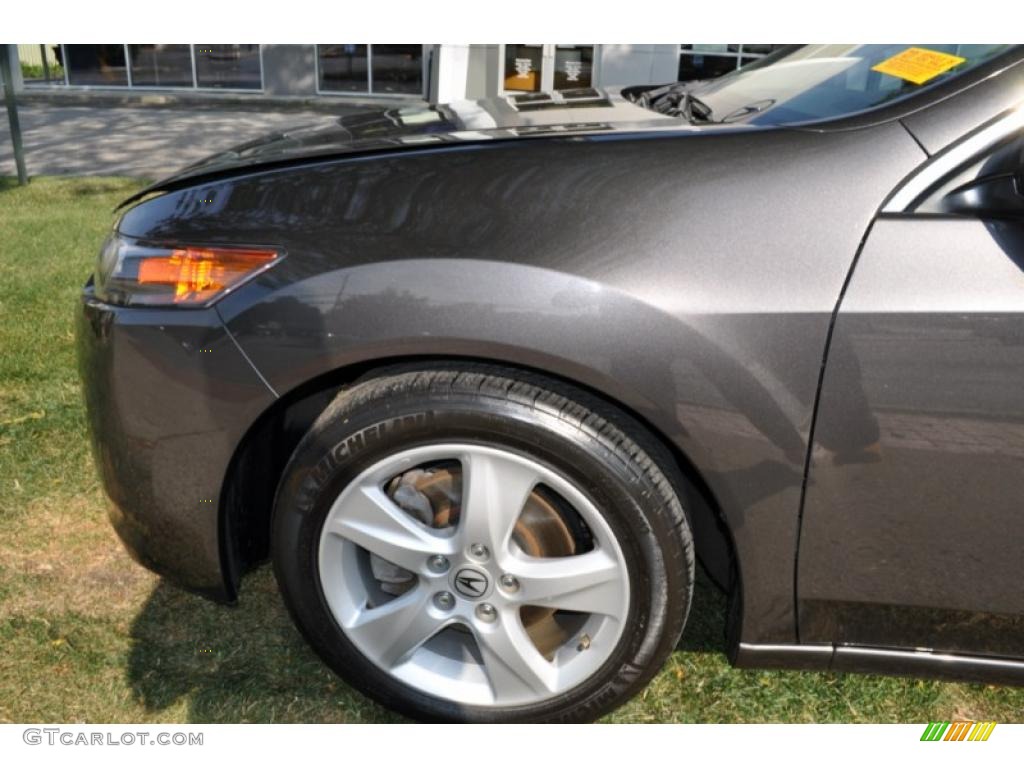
[0,178,1024,723]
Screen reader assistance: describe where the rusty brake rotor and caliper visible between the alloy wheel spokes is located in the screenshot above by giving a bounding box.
[370,461,577,658]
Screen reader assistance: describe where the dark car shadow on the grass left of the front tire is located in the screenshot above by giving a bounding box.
[127,567,398,723]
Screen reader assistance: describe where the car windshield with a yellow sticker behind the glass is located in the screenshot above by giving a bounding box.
[677,43,1013,125]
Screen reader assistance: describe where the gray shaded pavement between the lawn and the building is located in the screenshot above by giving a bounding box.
[0,104,341,179]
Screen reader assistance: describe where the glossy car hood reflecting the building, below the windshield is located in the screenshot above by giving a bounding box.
[122,88,690,206]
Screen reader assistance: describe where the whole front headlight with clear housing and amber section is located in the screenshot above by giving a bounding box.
[94,233,282,307]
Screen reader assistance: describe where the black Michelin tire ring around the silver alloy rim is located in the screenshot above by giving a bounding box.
[272,387,689,722]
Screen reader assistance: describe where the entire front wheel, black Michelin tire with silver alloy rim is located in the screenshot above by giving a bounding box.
[273,367,693,722]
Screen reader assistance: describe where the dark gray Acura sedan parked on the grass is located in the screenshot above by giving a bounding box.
[79,44,1024,721]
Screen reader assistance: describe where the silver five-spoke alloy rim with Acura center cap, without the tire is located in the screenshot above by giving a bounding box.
[318,443,630,707]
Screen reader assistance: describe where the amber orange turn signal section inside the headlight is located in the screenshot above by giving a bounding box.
[138,248,278,304]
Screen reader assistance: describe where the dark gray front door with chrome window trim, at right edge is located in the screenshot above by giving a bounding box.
[797,110,1024,657]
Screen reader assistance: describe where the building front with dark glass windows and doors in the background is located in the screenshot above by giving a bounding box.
[17,43,777,102]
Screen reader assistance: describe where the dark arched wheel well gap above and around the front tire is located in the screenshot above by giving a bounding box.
[220,356,740,614]
